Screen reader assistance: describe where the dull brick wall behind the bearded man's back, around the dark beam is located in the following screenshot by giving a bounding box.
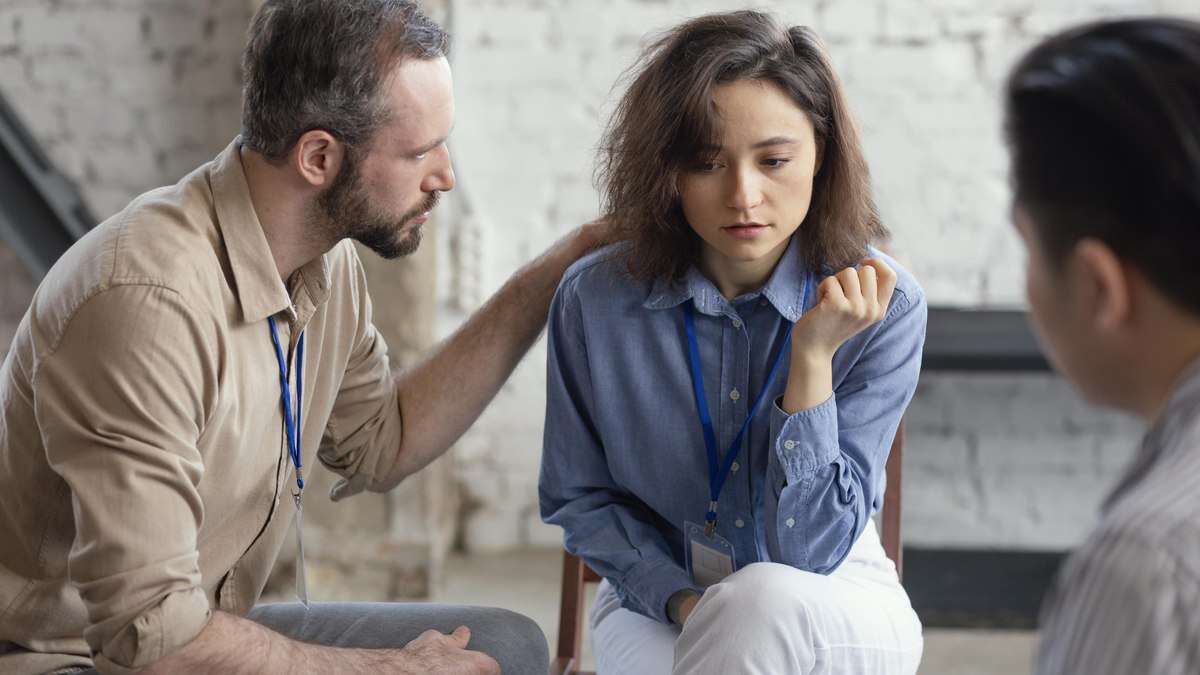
[0,0,250,353]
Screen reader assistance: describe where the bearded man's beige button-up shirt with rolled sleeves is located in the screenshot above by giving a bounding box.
[0,141,401,674]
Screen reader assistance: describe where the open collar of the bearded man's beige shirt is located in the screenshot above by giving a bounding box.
[209,137,329,323]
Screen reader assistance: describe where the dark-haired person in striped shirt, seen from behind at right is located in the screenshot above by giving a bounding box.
[1004,18,1200,675]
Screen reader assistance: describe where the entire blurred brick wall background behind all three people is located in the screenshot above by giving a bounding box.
[0,0,1200,598]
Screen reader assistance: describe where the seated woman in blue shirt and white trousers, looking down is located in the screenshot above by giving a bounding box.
[540,11,926,675]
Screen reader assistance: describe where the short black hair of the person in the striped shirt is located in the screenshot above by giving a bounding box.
[1006,18,1200,315]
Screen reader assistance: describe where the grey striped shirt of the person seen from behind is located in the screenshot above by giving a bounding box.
[1037,362,1200,675]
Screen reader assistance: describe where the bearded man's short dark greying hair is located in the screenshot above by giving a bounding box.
[241,0,448,161]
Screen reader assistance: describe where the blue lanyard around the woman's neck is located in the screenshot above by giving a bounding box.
[684,274,812,536]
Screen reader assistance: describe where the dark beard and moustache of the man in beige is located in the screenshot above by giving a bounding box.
[314,155,440,259]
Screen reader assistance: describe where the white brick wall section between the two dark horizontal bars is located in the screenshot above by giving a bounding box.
[904,375,1141,549]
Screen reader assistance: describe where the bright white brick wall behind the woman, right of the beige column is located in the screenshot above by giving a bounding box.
[440,0,1200,549]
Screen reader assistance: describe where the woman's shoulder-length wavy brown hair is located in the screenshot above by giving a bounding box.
[598,11,888,280]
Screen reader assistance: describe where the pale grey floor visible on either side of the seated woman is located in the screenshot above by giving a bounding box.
[433,550,1036,675]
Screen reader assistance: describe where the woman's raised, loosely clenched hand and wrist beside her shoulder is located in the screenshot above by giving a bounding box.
[784,258,896,414]
